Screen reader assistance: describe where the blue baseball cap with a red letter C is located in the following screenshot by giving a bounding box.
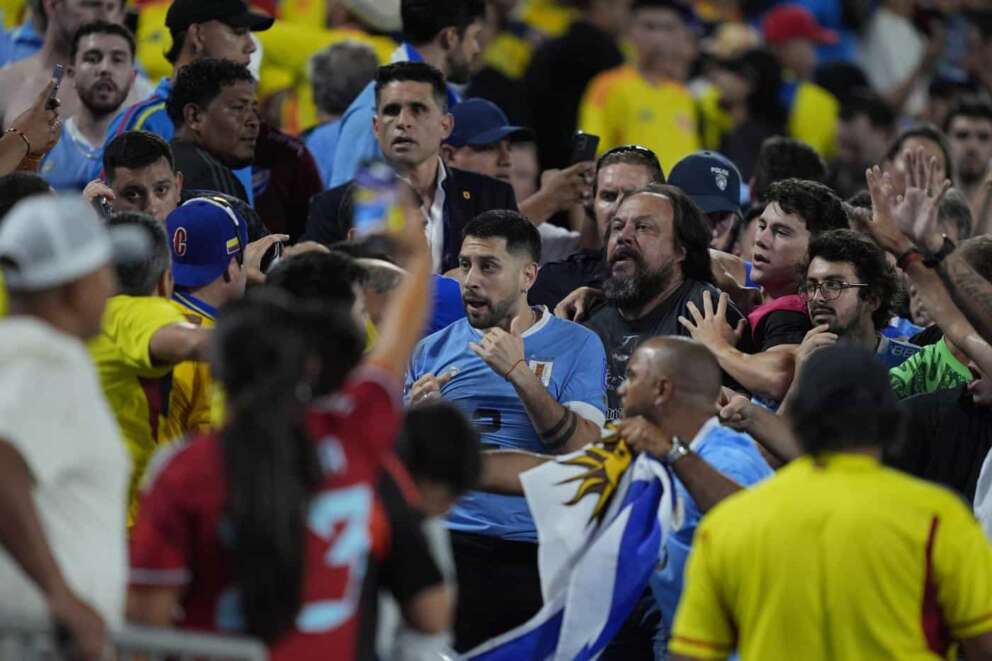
[166,197,248,289]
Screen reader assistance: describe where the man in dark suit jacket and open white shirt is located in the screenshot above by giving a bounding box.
[304,62,517,273]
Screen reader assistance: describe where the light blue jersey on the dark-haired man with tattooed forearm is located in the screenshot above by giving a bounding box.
[405,307,606,542]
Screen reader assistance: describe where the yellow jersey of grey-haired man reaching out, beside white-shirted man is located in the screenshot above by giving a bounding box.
[88,295,186,510]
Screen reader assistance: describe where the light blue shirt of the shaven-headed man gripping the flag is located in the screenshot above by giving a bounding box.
[650,418,772,631]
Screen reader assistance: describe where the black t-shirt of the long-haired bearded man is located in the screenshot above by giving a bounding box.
[585,280,743,420]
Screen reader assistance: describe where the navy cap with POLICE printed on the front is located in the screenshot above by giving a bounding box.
[668,151,741,213]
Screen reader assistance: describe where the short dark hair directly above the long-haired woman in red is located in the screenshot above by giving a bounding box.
[265,252,365,306]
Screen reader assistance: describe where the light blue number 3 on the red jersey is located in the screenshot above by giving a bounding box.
[296,485,372,633]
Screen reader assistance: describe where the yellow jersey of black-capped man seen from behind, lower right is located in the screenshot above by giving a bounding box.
[669,454,992,661]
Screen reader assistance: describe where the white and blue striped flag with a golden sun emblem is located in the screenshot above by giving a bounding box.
[465,441,679,661]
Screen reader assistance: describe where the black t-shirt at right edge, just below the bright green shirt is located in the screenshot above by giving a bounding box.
[885,387,992,503]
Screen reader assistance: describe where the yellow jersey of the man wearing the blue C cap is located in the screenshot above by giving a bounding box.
[162,291,217,440]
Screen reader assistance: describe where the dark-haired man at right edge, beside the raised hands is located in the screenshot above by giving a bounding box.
[944,99,992,235]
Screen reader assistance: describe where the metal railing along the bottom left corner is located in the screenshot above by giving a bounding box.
[0,613,269,661]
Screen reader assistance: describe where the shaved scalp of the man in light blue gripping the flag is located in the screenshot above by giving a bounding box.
[637,337,722,404]
